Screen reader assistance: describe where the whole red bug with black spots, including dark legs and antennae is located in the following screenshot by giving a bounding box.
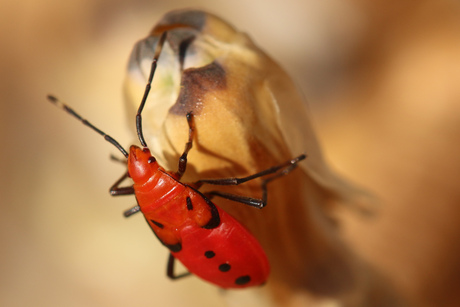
[48,32,306,288]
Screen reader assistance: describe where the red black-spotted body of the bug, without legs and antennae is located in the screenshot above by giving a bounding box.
[128,146,270,288]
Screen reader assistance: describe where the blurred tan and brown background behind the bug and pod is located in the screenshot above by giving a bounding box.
[0,0,460,306]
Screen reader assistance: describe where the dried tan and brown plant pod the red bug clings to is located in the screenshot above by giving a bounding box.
[126,11,395,306]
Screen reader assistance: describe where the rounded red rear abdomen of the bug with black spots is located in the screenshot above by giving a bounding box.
[172,209,270,288]
